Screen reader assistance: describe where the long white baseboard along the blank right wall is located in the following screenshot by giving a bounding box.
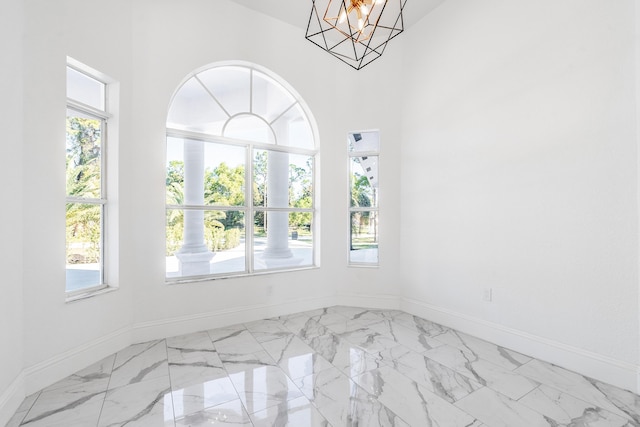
[400,298,640,393]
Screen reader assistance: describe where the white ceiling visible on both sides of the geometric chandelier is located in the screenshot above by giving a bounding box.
[231,0,445,30]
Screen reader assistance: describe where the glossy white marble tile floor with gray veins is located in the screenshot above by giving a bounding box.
[8,306,640,427]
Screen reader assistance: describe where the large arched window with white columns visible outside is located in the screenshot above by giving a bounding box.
[166,63,317,282]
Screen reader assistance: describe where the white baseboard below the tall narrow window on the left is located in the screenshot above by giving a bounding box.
[23,327,131,397]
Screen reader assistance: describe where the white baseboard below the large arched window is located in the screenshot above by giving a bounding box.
[133,296,336,342]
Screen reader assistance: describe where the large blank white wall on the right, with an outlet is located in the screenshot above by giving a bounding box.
[401,0,639,389]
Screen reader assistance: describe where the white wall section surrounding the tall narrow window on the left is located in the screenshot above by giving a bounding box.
[22,1,132,393]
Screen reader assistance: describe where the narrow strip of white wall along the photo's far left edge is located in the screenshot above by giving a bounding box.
[0,0,24,425]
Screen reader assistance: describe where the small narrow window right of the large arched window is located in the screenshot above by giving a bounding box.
[349,131,380,266]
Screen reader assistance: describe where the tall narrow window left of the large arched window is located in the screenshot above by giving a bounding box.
[66,61,109,295]
